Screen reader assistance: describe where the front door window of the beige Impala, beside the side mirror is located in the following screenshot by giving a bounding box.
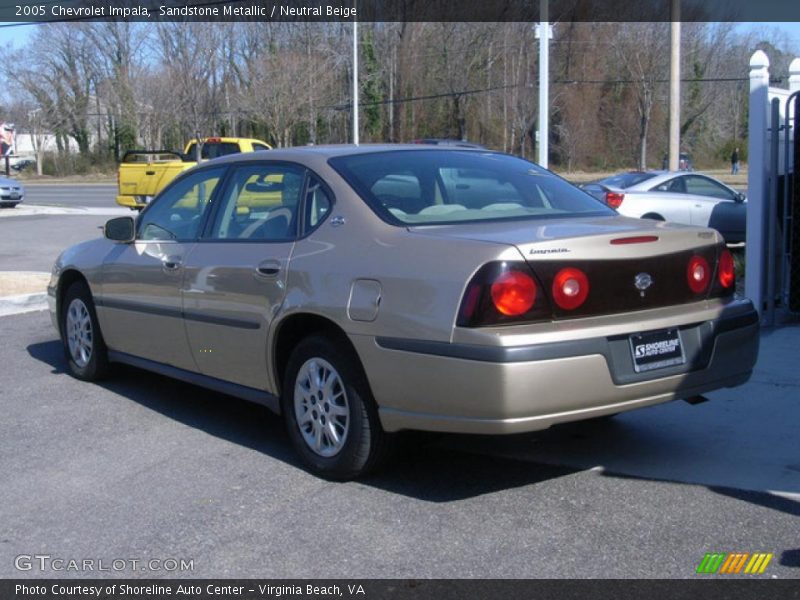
[137,167,225,241]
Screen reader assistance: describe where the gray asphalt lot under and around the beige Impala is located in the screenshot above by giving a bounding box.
[0,184,800,578]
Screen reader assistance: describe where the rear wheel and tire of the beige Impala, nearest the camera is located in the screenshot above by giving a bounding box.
[281,336,394,481]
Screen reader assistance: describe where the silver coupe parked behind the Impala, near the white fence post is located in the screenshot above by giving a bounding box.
[581,171,747,244]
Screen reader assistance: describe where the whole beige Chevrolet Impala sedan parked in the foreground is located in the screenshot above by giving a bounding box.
[49,146,758,479]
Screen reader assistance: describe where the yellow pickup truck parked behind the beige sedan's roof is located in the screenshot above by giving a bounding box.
[117,137,272,210]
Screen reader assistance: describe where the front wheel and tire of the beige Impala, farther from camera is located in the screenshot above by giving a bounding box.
[59,281,108,381]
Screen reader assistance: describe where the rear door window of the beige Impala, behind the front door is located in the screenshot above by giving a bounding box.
[210,164,305,242]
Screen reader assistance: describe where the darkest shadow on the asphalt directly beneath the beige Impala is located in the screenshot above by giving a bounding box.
[27,340,582,503]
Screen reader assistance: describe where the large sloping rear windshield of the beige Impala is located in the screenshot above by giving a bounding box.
[329,150,615,225]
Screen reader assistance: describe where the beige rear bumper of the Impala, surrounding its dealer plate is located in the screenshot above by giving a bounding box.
[351,301,759,434]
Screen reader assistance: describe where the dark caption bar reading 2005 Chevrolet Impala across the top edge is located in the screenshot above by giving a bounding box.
[0,0,800,23]
